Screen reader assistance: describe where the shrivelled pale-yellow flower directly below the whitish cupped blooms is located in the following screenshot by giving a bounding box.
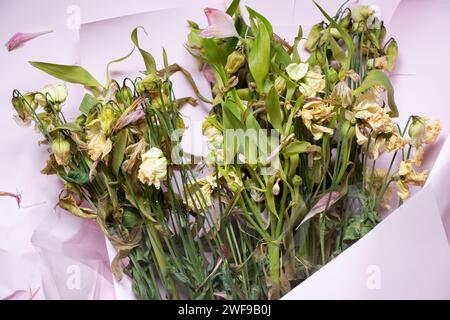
[300,100,334,140]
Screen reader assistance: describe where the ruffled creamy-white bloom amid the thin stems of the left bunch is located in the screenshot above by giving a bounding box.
[138,147,167,189]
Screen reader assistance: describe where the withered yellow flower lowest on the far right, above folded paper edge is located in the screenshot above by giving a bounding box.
[396,160,428,200]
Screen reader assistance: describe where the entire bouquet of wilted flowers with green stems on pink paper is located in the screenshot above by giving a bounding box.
[12,0,440,299]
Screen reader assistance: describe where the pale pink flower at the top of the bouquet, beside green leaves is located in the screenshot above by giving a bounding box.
[201,8,239,38]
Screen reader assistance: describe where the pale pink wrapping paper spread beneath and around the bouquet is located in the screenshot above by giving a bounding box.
[0,0,450,299]
